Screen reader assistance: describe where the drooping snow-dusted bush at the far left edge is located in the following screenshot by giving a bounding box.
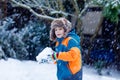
[0,18,28,60]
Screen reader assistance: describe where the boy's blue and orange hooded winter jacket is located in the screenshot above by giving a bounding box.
[55,31,82,80]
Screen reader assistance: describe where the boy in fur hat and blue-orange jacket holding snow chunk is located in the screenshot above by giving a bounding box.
[50,18,82,80]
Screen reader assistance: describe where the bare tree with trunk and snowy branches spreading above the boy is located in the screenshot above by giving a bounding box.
[10,0,89,34]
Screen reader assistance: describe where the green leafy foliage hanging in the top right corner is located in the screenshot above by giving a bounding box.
[93,0,120,23]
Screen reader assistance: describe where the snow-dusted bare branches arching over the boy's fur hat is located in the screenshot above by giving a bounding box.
[11,0,85,20]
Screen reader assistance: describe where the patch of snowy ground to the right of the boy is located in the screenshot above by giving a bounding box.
[83,66,120,80]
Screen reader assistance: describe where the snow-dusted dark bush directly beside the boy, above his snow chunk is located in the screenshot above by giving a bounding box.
[18,19,49,60]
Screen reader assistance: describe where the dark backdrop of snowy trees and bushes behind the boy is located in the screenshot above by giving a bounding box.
[0,0,120,75]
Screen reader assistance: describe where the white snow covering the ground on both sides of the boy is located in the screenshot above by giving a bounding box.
[0,58,120,80]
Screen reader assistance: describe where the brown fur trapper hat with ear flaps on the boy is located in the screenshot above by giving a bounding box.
[50,18,72,41]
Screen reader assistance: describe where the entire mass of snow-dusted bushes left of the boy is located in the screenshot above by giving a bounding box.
[0,17,49,60]
